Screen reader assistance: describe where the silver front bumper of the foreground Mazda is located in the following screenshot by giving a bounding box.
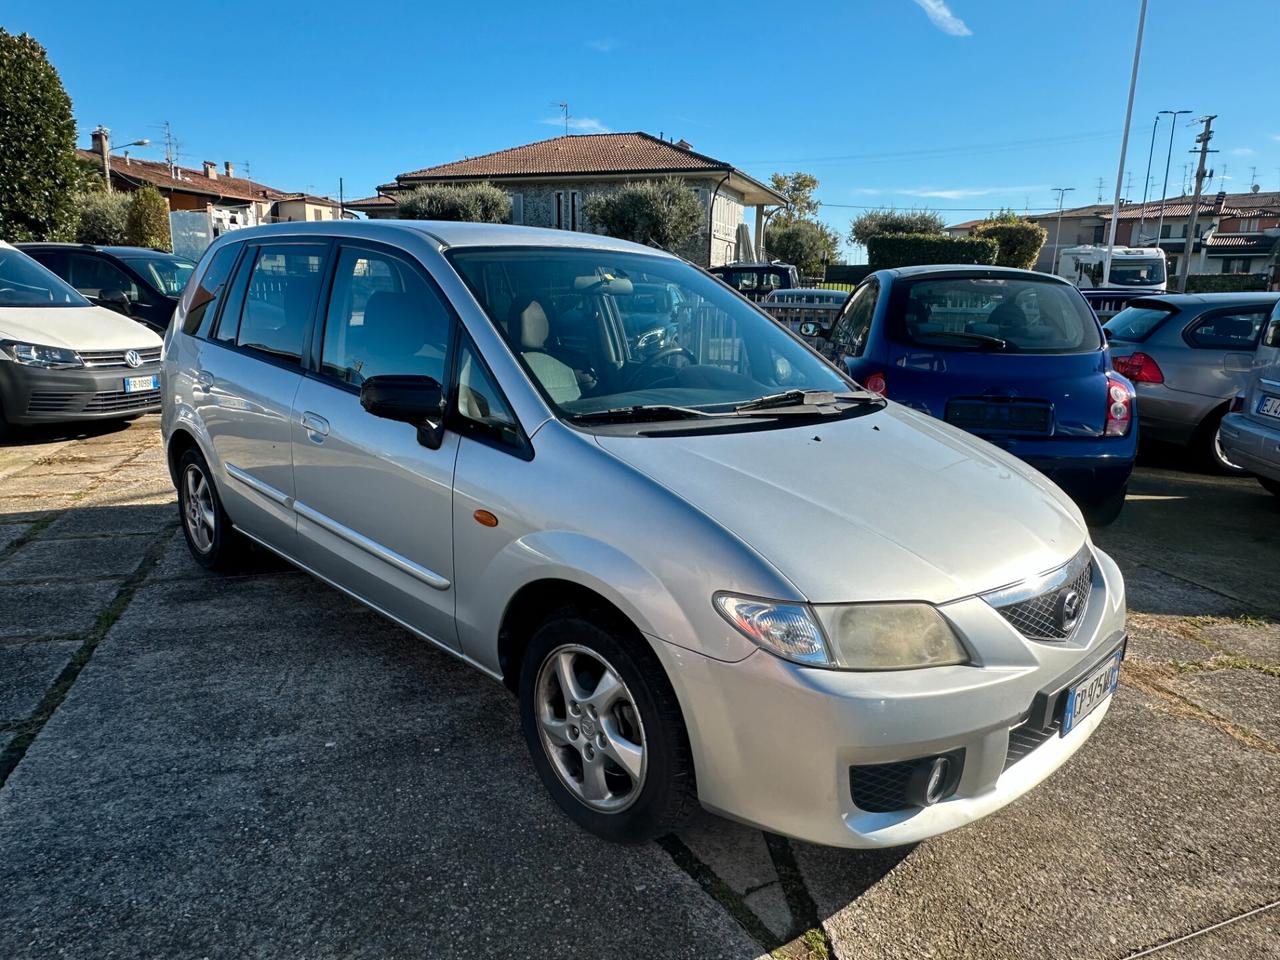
[654,550,1125,847]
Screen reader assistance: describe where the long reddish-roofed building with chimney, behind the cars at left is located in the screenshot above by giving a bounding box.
[83,127,342,236]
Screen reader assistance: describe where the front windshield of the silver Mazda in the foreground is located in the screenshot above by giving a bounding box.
[448,247,854,419]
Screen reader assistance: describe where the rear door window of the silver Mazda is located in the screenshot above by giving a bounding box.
[230,243,328,364]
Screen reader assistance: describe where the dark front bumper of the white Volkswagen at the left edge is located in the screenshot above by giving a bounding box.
[0,361,160,425]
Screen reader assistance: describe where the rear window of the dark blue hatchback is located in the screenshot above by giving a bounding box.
[890,276,1102,353]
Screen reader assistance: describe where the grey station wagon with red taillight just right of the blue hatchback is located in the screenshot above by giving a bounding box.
[1103,293,1280,472]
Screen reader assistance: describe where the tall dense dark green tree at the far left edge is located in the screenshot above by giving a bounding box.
[0,27,79,241]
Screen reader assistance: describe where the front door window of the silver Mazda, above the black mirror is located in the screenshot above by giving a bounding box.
[320,247,452,387]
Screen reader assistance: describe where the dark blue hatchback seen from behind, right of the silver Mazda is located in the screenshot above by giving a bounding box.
[801,266,1138,526]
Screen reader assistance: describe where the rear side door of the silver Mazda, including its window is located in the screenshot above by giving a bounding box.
[191,239,330,556]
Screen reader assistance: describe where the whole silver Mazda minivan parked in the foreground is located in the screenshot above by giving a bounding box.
[163,220,1125,847]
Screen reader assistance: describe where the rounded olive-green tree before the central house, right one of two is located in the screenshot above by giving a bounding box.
[582,178,707,250]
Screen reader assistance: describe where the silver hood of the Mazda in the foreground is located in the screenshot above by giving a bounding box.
[598,404,1088,603]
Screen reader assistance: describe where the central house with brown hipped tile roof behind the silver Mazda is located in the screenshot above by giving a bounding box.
[347,133,786,266]
